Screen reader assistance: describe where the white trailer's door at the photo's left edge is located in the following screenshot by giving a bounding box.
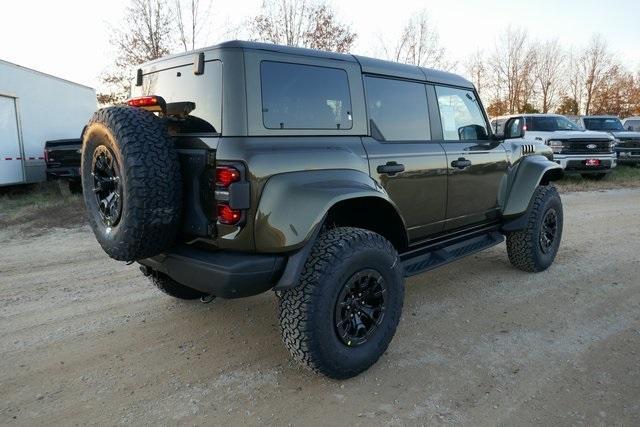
[0,95,24,185]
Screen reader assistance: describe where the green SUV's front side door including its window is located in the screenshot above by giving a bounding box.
[430,86,508,229]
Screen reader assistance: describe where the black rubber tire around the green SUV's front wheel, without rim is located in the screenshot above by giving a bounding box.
[507,185,563,273]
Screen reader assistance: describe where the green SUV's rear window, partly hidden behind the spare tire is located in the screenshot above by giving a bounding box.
[132,60,222,134]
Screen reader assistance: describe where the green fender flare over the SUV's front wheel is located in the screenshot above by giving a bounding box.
[502,155,563,218]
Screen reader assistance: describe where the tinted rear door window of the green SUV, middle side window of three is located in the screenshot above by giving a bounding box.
[364,76,431,141]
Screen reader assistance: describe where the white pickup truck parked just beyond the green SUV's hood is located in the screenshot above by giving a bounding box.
[491,114,616,180]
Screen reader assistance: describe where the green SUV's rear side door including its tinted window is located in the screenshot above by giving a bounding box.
[363,76,447,242]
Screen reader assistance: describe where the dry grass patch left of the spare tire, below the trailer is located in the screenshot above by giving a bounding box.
[0,182,86,229]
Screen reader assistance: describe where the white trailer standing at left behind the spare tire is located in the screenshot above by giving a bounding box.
[0,60,97,186]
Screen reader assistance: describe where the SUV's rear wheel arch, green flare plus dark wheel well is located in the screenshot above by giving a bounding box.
[254,170,407,252]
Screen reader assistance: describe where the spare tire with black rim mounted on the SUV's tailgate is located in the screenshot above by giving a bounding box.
[81,106,182,261]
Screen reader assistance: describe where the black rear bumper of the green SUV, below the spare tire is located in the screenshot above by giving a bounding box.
[138,246,286,298]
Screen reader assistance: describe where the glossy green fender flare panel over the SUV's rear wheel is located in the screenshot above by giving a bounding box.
[254,169,400,253]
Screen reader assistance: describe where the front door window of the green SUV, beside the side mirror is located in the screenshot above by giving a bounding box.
[436,86,489,141]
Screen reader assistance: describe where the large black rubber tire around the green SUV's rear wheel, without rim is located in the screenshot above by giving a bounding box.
[279,227,404,379]
